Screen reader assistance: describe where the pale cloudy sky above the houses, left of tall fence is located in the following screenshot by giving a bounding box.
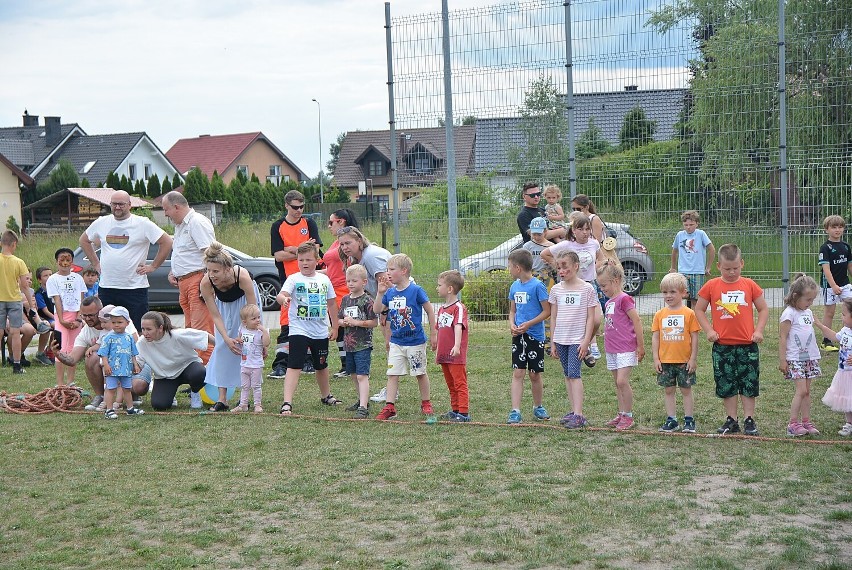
[0,0,684,176]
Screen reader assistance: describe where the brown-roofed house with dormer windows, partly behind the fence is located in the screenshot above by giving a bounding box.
[333,125,476,209]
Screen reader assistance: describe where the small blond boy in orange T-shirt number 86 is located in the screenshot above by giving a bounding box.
[651,273,701,433]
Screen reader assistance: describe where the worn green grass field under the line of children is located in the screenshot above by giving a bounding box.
[0,321,852,569]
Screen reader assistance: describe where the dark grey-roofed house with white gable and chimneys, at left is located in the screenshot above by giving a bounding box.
[0,111,178,186]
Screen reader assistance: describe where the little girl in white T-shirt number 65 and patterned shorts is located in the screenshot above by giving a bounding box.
[778,273,822,437]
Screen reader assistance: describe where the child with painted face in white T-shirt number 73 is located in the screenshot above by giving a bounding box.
[46,247,86,386]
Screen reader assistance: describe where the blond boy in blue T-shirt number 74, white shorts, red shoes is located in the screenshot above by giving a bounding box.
[373,253,436,422]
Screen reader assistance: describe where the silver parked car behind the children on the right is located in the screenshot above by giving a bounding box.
[459,222,654,296]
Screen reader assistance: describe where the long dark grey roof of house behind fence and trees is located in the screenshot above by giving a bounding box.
[475,85,688,188]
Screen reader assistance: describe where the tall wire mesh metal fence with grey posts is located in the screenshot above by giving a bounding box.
[386,0,852,336]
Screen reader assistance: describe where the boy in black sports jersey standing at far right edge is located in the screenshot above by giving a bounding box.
[819,216,852,352]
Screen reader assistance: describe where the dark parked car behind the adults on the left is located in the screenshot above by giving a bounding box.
[73,242,281,311]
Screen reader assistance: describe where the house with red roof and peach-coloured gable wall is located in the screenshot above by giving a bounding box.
[166,132,309,185]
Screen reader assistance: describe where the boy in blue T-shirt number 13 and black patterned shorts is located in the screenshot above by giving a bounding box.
[507,249,550,424]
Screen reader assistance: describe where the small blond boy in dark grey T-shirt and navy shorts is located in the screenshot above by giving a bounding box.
[337,263,379,420]
